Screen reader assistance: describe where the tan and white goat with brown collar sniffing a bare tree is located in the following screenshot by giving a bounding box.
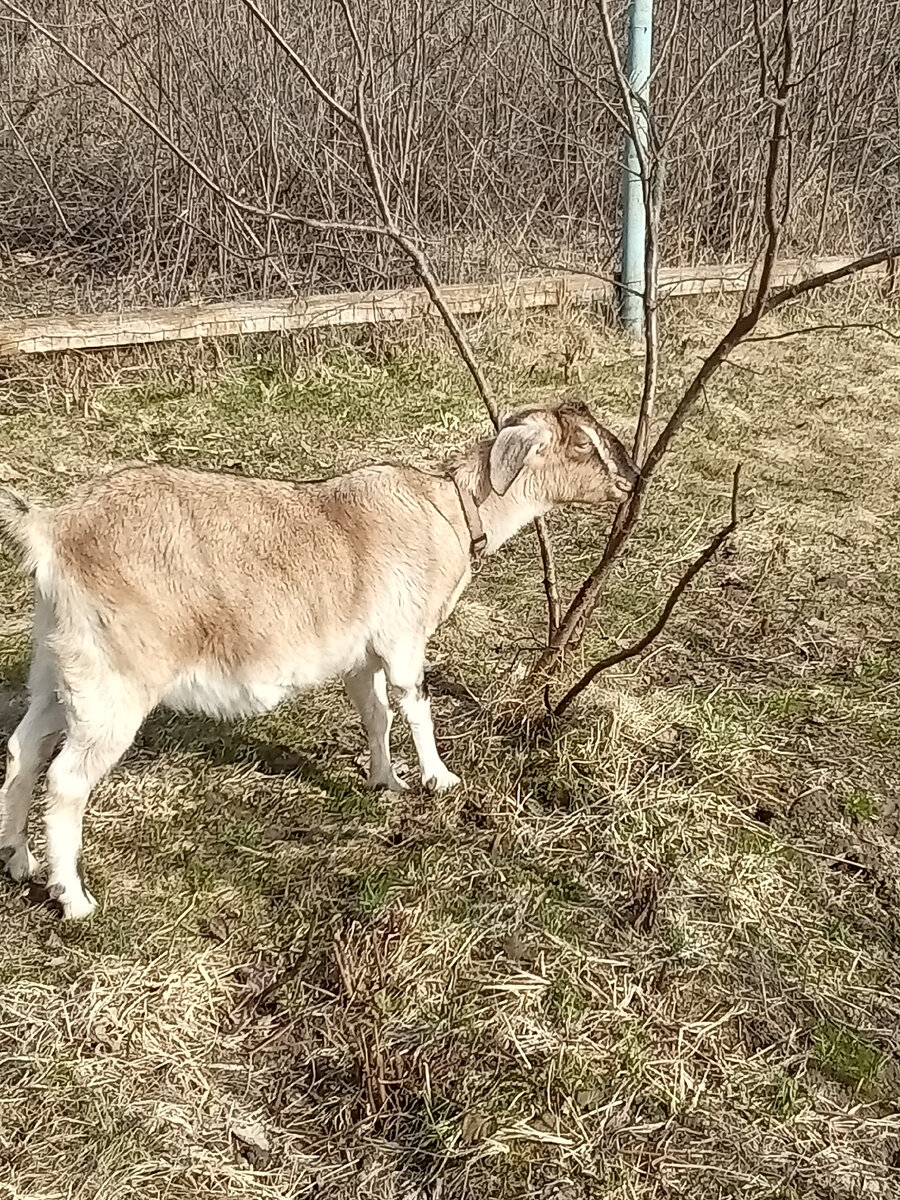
[0,401,637,918]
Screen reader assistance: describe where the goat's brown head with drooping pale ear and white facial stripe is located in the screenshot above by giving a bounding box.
[491,400,637,504]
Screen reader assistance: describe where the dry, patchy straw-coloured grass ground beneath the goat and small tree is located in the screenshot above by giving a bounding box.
[0,295,900,1200]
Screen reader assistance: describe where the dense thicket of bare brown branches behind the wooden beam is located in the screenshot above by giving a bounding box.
[0,0,900,311]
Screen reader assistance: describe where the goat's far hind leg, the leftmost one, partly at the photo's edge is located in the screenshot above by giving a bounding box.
[0,643,65,881]
